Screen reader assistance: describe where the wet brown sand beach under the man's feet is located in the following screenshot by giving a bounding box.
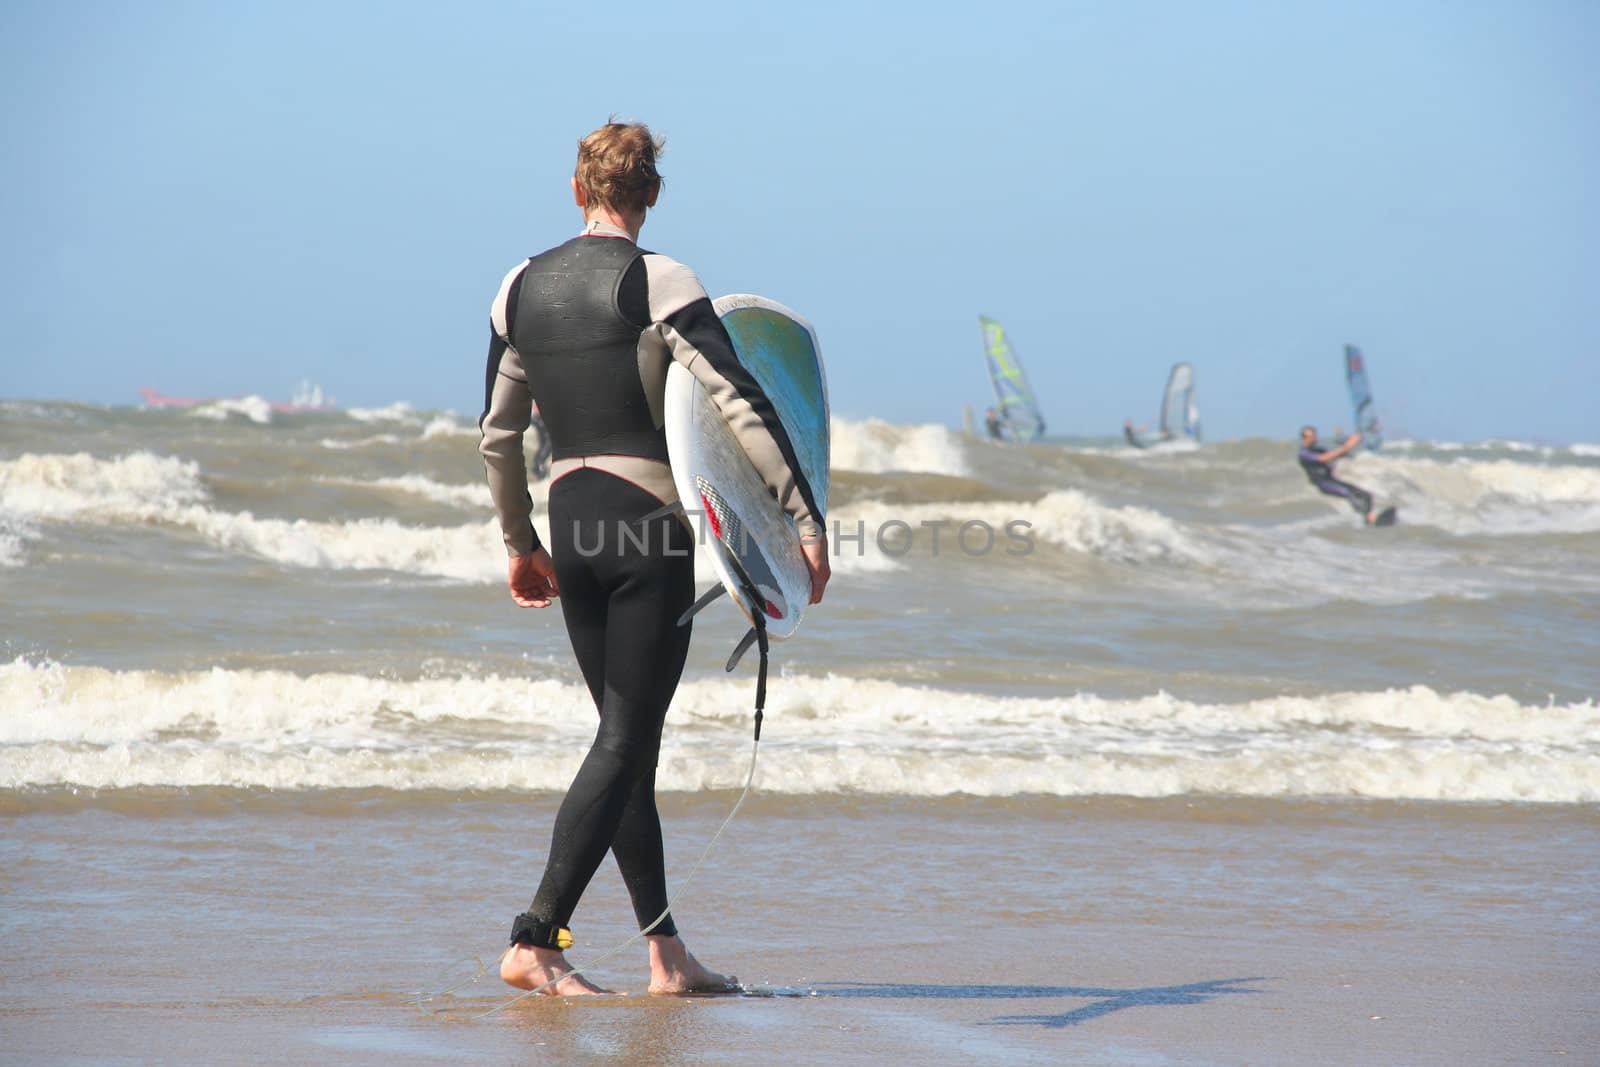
[0,790,1600,1065]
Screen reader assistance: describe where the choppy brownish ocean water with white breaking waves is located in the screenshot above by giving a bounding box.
[0,400,1600,813]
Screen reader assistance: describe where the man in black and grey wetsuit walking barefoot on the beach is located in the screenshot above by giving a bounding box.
[478,122,829,995]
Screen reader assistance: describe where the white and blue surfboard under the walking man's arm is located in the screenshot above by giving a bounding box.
[664,293,829,640]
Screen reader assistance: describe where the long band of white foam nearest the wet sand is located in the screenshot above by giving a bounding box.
[0,659,1600,803]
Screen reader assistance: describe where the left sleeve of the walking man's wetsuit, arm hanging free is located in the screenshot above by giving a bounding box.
[478,264,539,555]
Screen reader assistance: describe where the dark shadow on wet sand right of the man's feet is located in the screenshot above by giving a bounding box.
[813,977,1266,1029]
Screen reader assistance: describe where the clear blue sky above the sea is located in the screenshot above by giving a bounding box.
[0,0,1600,442]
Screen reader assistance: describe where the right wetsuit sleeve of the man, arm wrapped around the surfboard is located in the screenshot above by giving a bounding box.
[643,253,824,533]
